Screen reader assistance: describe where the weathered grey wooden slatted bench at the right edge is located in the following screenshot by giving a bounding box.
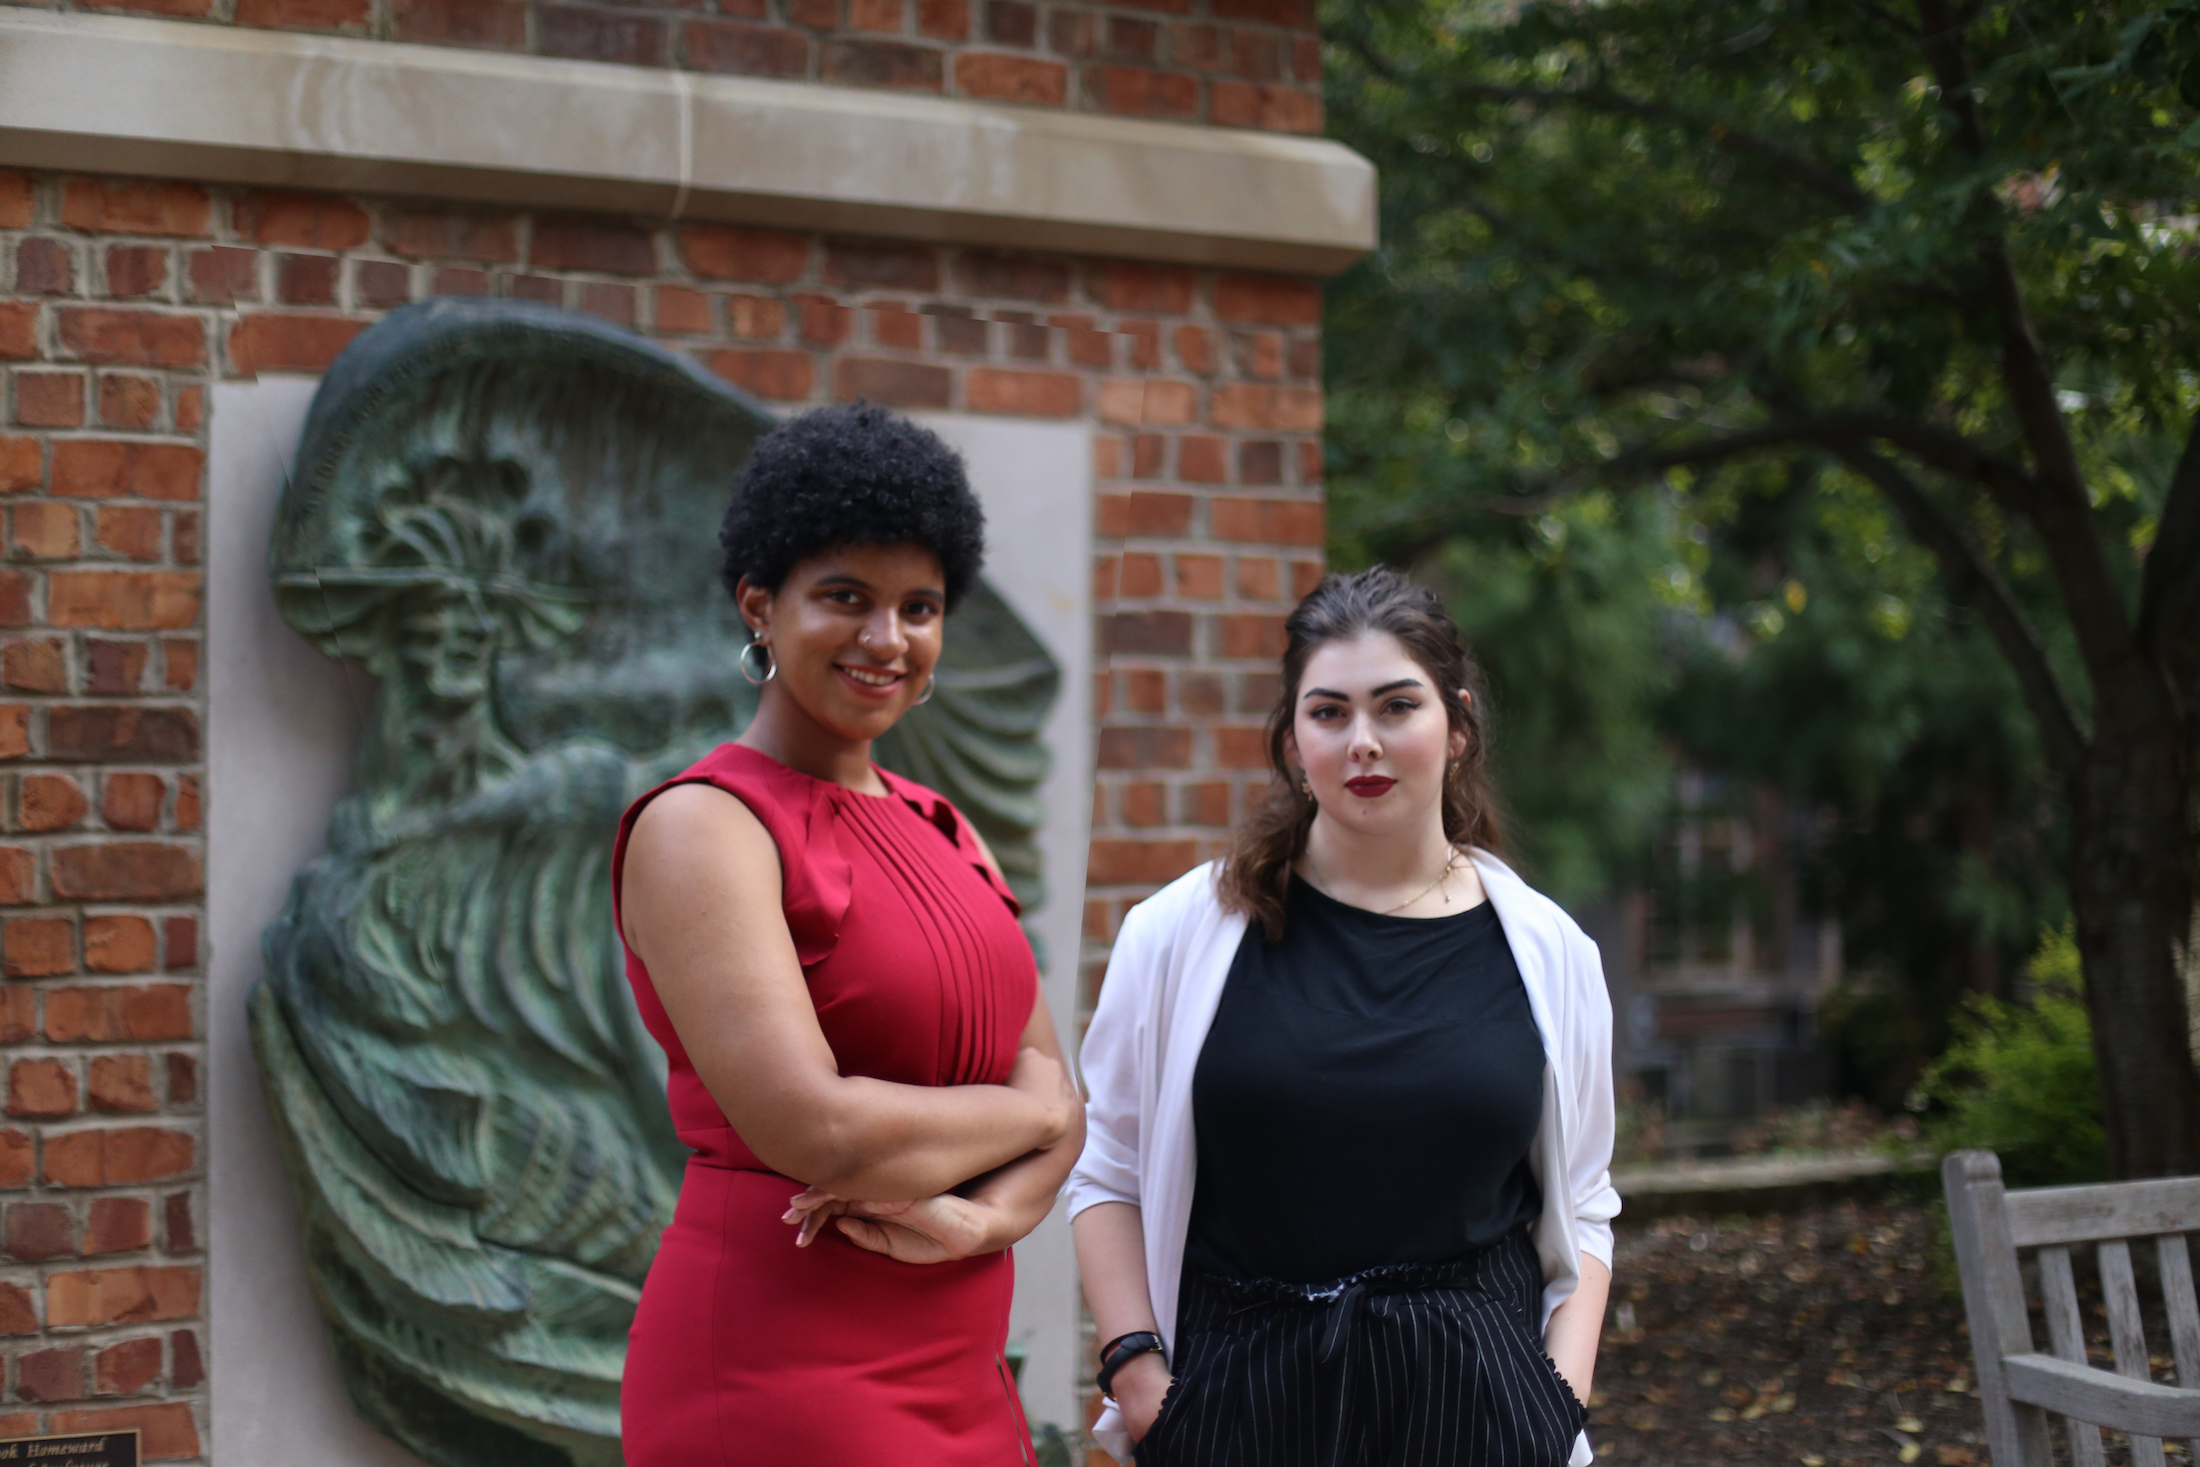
[1940,1150,2200,1467]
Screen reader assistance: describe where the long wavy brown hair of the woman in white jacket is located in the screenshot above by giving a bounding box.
[1217,565,1505,941]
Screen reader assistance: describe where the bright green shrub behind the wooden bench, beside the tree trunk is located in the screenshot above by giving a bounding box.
[1912,924,2108,1188]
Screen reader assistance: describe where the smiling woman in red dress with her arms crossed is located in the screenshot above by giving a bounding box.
[612,402,1085,1467]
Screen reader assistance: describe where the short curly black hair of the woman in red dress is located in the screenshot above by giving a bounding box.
[717,400,986,611]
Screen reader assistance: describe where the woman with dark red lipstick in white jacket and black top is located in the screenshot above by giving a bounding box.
[1069,567,1619,1467]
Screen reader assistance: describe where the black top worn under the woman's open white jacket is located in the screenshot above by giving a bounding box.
[1184,878,1544,1284]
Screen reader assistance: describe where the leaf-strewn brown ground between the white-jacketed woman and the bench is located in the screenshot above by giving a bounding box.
[1588,1199,2191,1467]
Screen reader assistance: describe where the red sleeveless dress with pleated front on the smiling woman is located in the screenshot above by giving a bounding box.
[612,743,1038,1467]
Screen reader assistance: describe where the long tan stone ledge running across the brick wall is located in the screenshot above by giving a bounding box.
[0,9,1375,275]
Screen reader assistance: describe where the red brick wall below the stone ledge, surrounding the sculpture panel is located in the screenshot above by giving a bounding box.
[0,172,1322,1458]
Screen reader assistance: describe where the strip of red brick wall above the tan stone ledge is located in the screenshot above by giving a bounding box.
[0,0,1322,132]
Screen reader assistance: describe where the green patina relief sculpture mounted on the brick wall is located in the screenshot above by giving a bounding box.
[251,301,1058,1467]
